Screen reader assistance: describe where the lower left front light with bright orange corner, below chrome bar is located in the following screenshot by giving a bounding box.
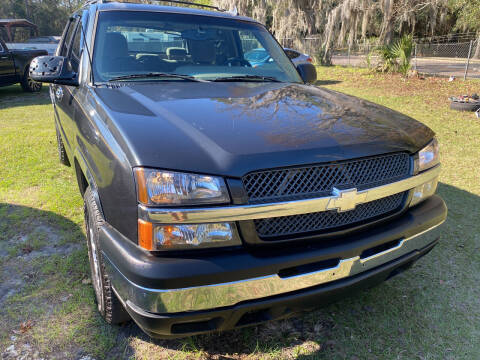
[138,220,241,251]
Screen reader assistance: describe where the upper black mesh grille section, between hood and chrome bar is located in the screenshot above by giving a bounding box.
[242,153,410,203]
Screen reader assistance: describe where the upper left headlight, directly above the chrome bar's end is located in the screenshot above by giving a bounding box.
[135,168,230,206]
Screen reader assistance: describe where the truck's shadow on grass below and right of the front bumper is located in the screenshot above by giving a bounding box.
[117,184,480,359]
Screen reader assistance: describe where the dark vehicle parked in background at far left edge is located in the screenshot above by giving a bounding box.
[0,39,48,92]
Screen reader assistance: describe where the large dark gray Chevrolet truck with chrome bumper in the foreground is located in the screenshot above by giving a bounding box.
[30,1,447,337]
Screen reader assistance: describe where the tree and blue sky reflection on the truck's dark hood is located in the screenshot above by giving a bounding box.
[215,85,423,147]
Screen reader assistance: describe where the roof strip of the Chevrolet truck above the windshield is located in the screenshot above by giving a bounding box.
[91,2,258,23]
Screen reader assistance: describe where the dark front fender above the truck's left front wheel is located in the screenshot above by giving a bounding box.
[72,88,138,241]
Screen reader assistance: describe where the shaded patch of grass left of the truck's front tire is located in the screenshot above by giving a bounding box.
[0,203,117,359]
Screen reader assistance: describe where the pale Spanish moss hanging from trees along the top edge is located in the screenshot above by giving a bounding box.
[214,0,452,63]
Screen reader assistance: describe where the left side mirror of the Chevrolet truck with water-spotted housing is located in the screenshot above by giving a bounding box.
[30,56,79,86]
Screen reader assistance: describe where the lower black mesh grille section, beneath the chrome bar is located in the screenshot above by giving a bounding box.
[254,193,405,240]
